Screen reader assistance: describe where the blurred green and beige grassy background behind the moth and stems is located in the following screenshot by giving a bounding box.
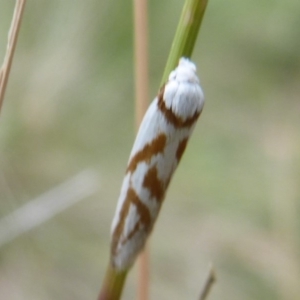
[0,0,300,300]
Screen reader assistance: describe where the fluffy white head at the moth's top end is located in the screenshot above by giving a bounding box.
[169,57,199,83]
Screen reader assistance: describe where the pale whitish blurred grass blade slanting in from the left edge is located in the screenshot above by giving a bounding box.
[0,169,99,248]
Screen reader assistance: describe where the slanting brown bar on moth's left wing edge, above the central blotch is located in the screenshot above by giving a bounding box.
[126,133,167,173]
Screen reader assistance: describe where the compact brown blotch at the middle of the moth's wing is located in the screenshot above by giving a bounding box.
[143,166,165,202]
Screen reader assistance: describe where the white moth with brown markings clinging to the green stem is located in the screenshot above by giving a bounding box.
[111,58,204,271]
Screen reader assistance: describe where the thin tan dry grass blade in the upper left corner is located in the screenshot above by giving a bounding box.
[0,0,26,112]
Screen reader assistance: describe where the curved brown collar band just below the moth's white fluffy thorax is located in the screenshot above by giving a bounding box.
[158,86,201,128]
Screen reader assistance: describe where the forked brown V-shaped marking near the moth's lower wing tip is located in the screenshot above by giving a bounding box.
[111,187,151,256]
